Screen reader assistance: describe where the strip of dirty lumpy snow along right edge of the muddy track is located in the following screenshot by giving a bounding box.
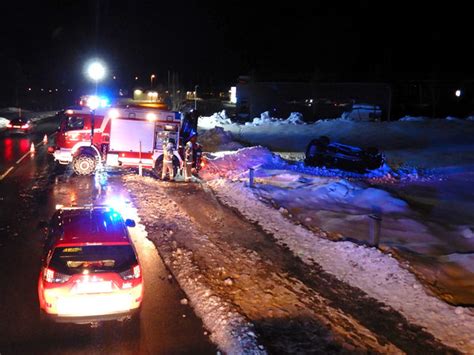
[209,179,474,353]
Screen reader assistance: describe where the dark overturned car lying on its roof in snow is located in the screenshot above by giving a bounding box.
[304,136,385,173]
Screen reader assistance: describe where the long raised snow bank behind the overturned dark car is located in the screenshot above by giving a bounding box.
[200,113,474,157]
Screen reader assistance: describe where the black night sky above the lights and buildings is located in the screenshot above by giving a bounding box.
[0,0,474,90]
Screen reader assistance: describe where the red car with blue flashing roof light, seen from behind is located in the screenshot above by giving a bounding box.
[38,206,143,323]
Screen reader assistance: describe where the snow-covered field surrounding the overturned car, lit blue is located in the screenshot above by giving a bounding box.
[195,112,474,305]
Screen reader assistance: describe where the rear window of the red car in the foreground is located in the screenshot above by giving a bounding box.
[49,245,137,275]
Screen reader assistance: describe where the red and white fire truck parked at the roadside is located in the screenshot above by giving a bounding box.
[48,107,188,175]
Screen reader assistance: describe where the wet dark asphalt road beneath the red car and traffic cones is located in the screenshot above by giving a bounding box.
[0,119,216,354]
